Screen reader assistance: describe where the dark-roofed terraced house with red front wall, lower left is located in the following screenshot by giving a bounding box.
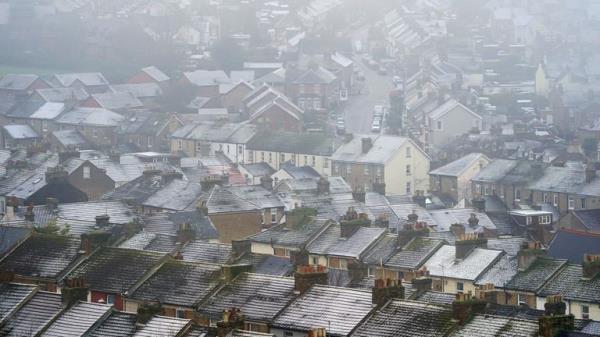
[65,247,167,310]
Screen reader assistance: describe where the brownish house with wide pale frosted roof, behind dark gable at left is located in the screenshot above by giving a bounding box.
[56,108,125,147]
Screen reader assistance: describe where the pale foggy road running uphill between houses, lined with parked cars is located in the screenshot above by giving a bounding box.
[342,26,393,133]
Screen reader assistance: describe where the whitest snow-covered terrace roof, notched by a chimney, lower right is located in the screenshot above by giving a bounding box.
[425,245,504,281]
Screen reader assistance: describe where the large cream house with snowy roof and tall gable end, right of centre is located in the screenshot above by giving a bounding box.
[331,135,430,195]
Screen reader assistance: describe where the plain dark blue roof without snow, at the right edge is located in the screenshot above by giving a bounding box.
[548,228,600,263]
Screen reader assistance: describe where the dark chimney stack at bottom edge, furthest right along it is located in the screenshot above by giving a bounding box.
[538,295,575,337]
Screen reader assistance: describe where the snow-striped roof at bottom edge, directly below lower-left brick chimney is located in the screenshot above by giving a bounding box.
[41,302,112,337]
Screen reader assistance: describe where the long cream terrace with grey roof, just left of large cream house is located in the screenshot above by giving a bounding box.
[244,131,337,176]
